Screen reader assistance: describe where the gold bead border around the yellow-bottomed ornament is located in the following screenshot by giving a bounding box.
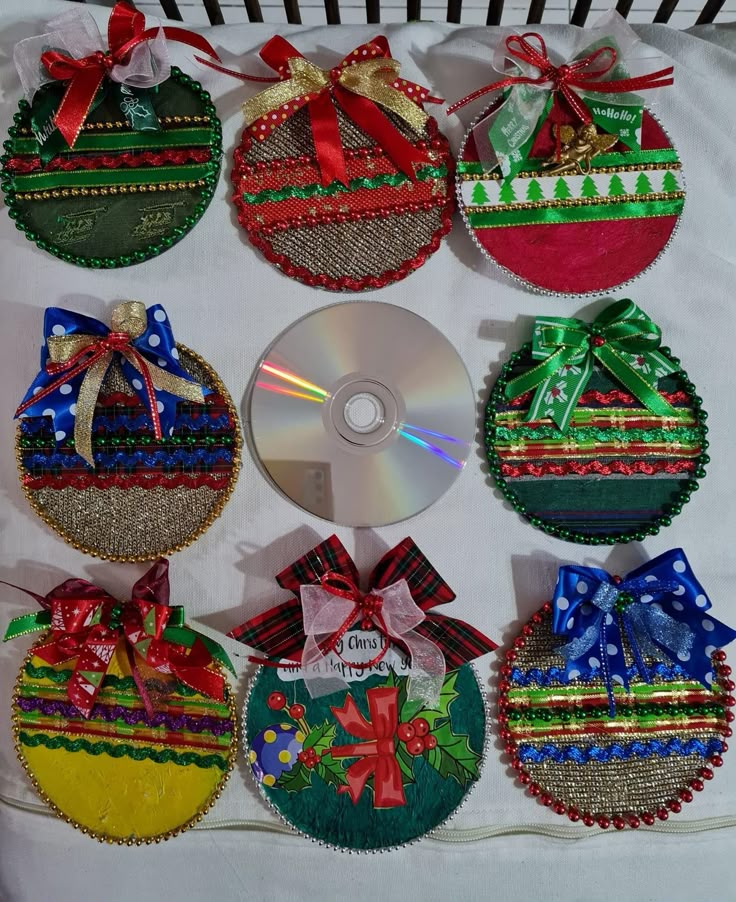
[13,644,238,846]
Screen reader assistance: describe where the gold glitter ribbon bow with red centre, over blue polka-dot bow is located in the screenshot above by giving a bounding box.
[44,301,204,467]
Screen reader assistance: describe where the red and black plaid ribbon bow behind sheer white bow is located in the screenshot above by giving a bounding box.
[228,535,498,670]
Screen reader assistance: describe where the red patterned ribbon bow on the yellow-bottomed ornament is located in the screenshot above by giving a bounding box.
[22,558,225,717]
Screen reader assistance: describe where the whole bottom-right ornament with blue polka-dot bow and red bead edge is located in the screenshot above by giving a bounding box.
[498,548,736,830]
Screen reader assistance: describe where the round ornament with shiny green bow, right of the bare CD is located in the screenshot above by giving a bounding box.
[485,300,709,545]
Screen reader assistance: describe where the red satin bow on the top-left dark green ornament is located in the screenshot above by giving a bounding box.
[41,0,220,147]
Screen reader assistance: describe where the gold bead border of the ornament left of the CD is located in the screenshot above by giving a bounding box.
[15,342,243,564]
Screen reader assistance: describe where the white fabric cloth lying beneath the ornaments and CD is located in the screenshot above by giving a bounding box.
[0,0,736,902]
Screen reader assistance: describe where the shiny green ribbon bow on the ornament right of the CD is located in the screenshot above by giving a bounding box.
[505,300,679,432]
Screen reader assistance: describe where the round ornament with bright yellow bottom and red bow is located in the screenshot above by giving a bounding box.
[5,559,237,845]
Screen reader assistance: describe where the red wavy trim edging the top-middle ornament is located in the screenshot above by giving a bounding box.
[230,117,455,291]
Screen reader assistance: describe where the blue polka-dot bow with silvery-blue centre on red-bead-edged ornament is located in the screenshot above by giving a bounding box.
[552,548,736,717]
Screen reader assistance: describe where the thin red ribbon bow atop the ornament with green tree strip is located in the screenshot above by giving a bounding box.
[447,31,674,125]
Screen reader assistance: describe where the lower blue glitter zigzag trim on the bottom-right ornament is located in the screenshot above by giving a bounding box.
[517,737,723,764]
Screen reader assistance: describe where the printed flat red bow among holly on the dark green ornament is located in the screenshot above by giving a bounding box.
[330,686,406,808]
